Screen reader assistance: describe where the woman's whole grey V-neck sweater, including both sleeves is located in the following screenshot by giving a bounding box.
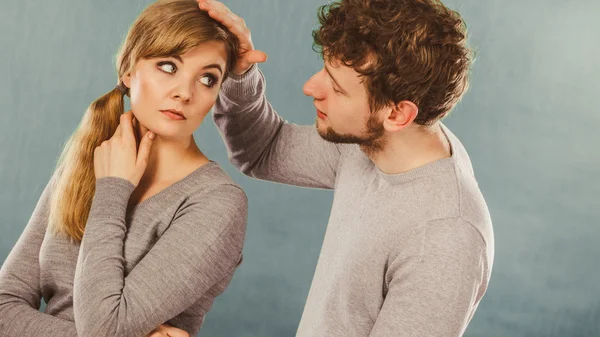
[0,162,247,337]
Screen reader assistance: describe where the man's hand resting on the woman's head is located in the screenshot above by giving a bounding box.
[196,0,267,75]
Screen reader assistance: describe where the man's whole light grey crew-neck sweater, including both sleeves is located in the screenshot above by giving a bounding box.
[214,66,494,337]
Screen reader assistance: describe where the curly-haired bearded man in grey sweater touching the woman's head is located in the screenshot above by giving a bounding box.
[198,0,494,337]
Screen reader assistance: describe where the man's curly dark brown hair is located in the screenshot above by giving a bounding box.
[313,0,472,125]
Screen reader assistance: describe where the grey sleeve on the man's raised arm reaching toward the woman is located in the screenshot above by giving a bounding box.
[213,65,341,189]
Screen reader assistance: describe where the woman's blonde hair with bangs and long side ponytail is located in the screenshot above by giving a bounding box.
[48,0,239,242]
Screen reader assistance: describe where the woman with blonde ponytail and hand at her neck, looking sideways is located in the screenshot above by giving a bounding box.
[0,0,247,337]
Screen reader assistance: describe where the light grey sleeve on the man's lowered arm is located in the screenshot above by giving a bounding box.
[369,218,489,337]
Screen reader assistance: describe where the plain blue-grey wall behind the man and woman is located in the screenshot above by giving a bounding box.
[0,0,600,337]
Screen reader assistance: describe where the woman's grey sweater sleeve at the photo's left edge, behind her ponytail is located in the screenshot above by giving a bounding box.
[0,175,77,337]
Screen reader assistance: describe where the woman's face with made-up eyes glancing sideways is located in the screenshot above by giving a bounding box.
[123,41,227,139]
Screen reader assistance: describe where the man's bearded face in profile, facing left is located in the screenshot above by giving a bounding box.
[303,59,384,147]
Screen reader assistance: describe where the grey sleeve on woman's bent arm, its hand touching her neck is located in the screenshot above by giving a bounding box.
[73,177,247,337]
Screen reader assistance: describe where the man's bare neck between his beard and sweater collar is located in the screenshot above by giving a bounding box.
[365,123,452,174]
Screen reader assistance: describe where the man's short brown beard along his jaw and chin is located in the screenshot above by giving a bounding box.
[315,114,385,155]
